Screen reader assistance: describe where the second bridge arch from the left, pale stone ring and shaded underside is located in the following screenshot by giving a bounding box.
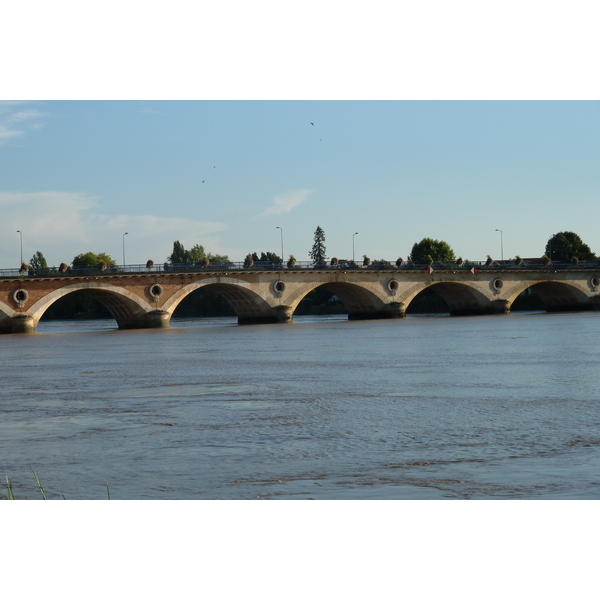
[162,277,288,325]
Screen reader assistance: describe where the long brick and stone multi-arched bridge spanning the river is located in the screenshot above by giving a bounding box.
[0,263,600,333]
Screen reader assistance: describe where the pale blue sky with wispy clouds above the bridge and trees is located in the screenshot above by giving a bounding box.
[0,100,600,268]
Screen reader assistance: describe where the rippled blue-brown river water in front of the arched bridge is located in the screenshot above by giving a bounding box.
[0,313,600,500]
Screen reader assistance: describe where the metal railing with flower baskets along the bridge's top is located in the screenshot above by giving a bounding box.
[0,259,600,278]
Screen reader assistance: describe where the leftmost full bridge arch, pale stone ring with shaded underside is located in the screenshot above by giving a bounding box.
[27,281,160,329]
